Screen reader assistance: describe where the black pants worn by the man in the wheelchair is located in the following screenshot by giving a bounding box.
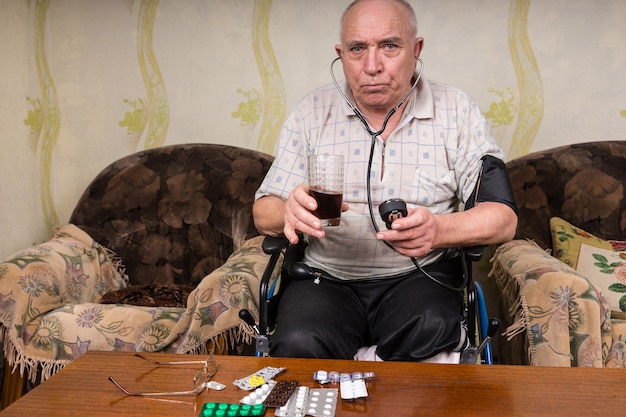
[270,258,463,361]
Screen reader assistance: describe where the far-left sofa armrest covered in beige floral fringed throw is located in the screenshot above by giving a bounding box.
[0,224,127,381]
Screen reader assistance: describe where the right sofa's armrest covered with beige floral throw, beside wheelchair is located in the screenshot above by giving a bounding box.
[491,240,610,367]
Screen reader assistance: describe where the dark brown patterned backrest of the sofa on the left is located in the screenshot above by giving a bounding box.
[70,144,273,286]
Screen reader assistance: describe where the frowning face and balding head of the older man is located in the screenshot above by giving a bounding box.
[335,1,423,114]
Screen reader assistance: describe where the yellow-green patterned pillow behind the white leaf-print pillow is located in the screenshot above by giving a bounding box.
[550,217,613,269]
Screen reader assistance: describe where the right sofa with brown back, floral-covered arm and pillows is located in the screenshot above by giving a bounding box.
[491,141,626,368]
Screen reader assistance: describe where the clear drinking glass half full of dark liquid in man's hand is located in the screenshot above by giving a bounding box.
[308,154,344,226]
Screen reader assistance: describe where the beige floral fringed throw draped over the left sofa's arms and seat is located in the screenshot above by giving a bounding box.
[0,224,267,381]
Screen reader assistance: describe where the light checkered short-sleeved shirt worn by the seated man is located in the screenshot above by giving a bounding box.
[256,79,504,279]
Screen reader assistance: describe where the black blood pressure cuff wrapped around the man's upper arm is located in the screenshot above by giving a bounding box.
[465,155,517,214]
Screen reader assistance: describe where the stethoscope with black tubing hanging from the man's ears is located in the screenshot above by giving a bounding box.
[330,56,467,291]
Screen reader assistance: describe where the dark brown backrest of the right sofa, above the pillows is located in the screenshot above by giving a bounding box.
[507,141,626,249]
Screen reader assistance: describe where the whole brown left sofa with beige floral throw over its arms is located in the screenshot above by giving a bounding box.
[0,143,273,405]
